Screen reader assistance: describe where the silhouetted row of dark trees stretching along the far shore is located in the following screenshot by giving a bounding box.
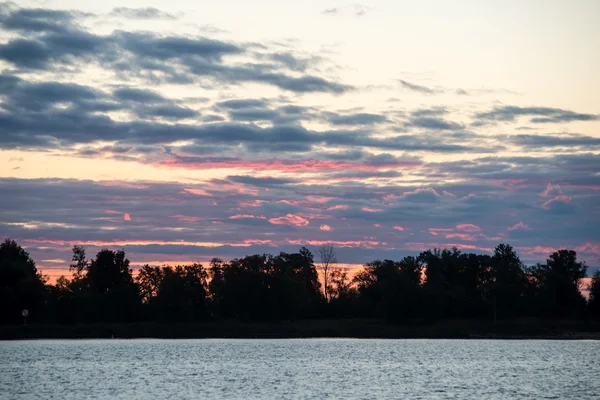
[0,239,600,324]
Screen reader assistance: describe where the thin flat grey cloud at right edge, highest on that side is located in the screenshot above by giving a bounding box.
[476,106,598,123]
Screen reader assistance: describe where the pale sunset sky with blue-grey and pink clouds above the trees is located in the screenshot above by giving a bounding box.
[0,0,600,275]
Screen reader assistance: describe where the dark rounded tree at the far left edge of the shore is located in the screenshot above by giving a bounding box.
[0,239,46,323]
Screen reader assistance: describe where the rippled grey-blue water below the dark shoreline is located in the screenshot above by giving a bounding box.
[0,339,600,399]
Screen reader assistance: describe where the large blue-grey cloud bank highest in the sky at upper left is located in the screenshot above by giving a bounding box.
[0,8,353,93]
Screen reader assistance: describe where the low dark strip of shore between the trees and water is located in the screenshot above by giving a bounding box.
[0,319,600,340]
